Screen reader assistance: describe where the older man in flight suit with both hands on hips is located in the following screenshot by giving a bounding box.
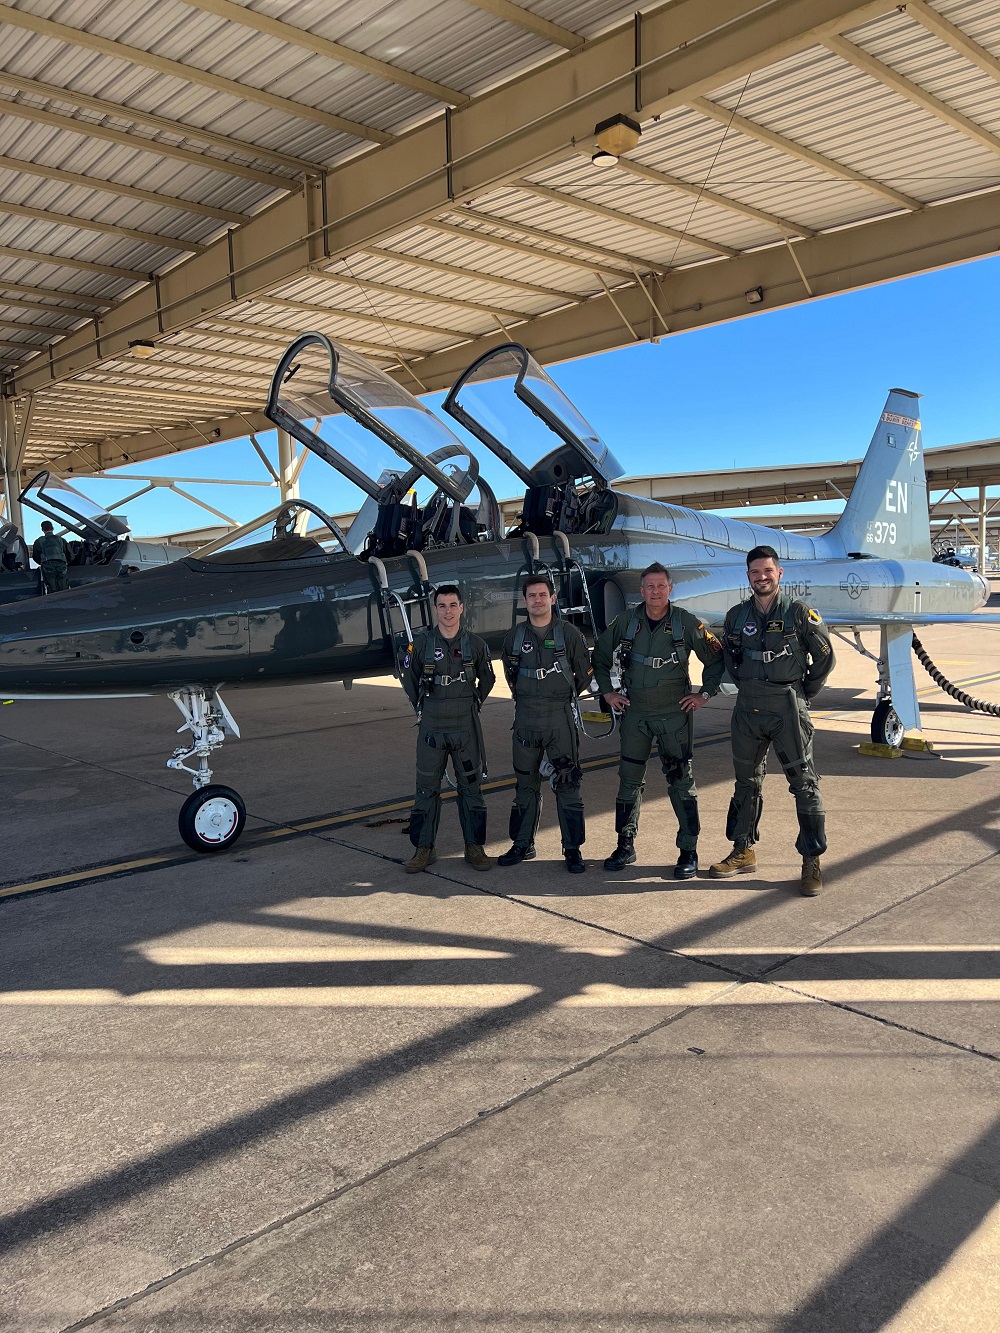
[593,561,724,880]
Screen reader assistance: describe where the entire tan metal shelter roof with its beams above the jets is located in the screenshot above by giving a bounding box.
[0,0,1000,481]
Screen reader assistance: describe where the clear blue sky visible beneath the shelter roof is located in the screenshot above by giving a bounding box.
[56,247,1000,535]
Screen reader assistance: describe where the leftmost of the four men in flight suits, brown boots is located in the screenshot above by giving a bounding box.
[403,584,496,874]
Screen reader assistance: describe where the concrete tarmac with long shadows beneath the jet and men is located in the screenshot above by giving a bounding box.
[0,613,1000,1333]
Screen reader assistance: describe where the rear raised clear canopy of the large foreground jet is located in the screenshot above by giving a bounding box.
[444,343,624,488]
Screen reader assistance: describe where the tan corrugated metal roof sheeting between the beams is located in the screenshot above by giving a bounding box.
[0,0,1000,479]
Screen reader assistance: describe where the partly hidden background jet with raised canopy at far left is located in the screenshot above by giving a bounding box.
[0,472,187,603]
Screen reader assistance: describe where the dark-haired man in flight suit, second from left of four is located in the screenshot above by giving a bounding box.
[497,573,591,874]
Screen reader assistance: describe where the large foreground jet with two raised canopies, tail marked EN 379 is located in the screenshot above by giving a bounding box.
[0,333,1000,852]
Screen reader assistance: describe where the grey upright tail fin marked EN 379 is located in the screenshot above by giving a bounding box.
[831,389,932,560]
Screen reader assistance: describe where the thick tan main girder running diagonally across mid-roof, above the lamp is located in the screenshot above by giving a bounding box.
[3,0,895,395]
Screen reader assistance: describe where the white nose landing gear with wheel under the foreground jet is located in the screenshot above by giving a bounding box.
[167,685,247,852]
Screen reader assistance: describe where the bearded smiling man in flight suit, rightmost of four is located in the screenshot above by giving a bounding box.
[708,547,835,897]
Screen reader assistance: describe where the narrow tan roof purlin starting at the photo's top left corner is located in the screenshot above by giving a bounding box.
[0,4,392,144]
